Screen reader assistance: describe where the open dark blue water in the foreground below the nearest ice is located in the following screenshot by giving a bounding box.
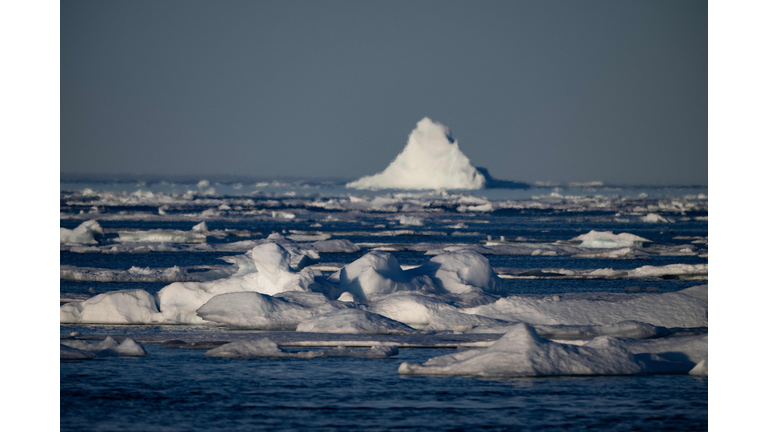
[60,345,707,431]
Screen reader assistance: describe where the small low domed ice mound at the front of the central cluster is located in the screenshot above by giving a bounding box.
[296,309,415,334]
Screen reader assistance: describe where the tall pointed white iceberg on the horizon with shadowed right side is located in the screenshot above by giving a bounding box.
[346,117,528,189]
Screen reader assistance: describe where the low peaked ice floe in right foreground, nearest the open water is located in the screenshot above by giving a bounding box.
[399,324,689,377]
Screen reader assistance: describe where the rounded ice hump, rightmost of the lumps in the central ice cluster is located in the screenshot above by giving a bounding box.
[407,250,506,294]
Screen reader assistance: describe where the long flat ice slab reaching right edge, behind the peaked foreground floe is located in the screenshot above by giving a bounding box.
[462,287,708,328]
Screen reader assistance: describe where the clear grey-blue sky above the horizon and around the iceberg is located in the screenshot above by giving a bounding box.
[60,0,708,185]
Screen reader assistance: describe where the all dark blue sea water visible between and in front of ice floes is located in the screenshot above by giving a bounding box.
[60,190,708,431]
